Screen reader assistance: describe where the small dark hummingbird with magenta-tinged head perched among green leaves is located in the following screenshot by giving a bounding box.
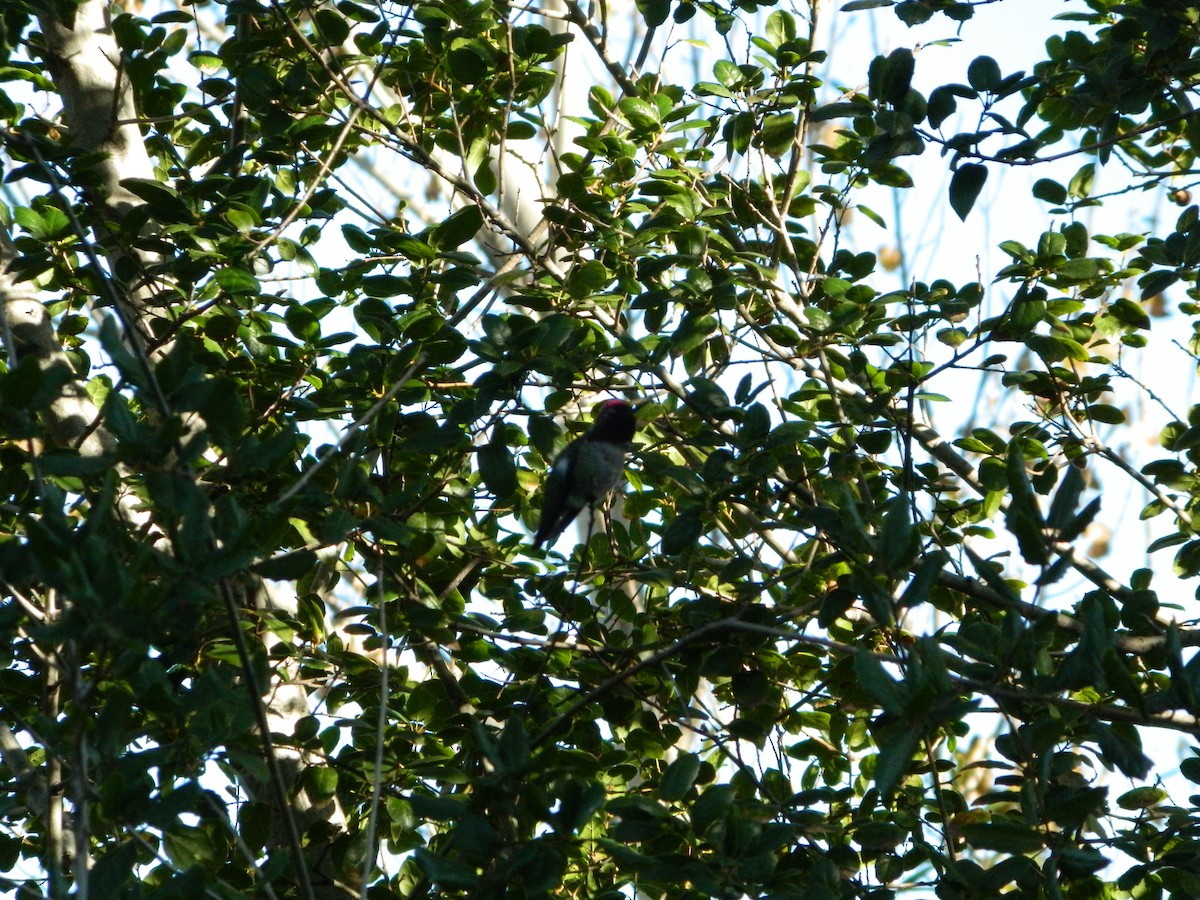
[533,400,637,547]
